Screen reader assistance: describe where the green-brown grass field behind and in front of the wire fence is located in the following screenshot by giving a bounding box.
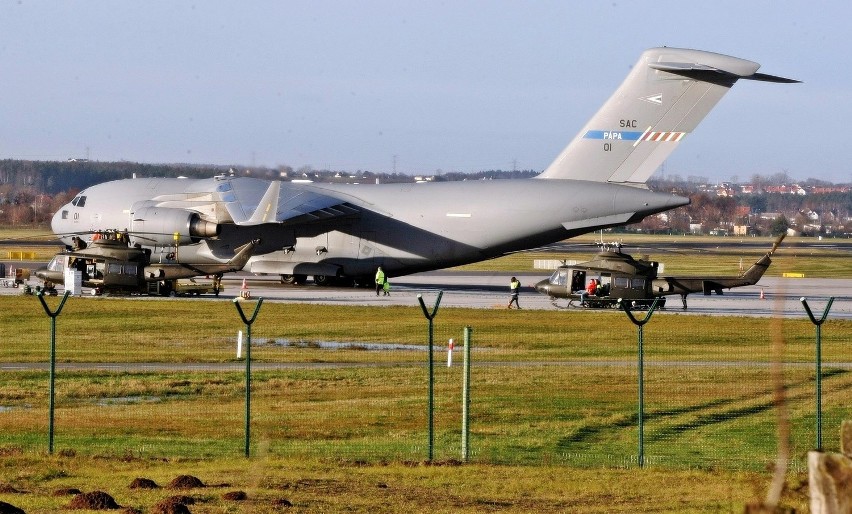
[0,296,852,512]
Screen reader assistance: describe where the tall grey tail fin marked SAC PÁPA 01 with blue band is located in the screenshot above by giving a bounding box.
[537,47,798,185]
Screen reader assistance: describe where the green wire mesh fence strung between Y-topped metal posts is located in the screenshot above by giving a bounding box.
[0,298,852,469]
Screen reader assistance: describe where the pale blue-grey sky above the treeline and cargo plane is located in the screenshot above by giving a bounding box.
[0,0,852,182]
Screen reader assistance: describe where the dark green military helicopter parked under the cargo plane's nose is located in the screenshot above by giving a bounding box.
[35,230,259,295]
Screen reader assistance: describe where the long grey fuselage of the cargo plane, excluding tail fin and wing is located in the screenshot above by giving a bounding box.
[52,178,688,277]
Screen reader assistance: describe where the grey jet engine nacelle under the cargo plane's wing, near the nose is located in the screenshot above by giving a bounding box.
[130,207,219,246]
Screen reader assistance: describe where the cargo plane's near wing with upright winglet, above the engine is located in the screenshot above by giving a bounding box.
[218,178,360,225]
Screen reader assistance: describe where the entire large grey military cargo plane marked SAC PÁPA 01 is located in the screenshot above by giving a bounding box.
[52,48,798,284]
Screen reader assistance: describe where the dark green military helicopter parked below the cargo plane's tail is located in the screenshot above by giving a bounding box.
[535,235,784,310]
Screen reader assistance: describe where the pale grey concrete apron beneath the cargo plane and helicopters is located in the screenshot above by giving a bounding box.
[0,271,852,319]
